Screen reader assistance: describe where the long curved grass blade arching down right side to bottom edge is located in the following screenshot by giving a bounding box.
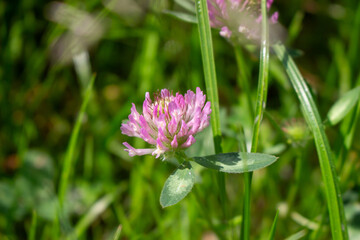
[273,44,348,240]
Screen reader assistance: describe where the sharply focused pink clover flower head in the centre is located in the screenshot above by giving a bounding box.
[120,88,211,158]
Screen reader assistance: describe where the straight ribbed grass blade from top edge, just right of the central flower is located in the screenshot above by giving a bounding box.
[196,0,227,223]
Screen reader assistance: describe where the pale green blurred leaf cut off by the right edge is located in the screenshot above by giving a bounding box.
[327,86,360,125]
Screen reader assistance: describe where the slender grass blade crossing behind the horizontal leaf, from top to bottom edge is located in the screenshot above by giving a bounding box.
[241,0,269,240]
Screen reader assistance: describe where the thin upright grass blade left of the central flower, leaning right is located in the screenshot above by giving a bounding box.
[59,74,96,208]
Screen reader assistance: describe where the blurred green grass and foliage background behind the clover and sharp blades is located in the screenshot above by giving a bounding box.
[0,0,360,239]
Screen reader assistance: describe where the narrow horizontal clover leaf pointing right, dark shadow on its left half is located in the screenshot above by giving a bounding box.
[194,152,277,173]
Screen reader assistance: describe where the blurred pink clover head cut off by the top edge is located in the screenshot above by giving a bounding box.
[207,0,279,40]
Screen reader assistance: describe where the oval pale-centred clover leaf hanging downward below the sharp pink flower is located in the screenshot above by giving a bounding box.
[160,161,195,208]
